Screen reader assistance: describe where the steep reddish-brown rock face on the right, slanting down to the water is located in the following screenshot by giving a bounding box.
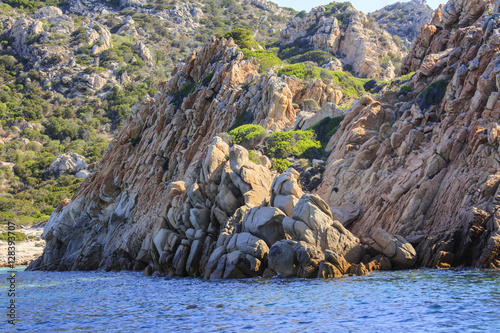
[316,1,500,267]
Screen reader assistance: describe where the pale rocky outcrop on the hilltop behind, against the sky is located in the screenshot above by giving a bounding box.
[281,3,405,80]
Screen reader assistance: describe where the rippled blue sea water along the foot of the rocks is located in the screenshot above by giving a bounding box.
[0,270,500,332]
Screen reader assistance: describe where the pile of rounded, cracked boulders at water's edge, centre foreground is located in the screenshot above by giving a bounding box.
[134,137,418,279]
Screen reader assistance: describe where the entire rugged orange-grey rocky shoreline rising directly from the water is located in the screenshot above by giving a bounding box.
[29,0,500,279]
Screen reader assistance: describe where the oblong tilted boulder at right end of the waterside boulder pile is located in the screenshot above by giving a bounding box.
[366,228,417,268]
